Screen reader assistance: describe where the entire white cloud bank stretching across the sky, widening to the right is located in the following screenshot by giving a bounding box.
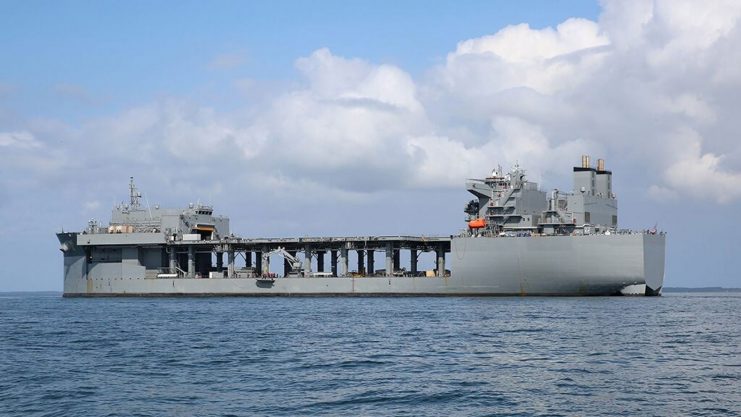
[0,0,741,202]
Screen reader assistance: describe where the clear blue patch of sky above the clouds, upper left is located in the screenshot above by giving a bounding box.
[0,1,599,121]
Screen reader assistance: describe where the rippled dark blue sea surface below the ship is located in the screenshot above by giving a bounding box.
[0,293,741,416]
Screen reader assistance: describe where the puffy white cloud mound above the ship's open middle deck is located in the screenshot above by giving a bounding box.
[241,49,429,191]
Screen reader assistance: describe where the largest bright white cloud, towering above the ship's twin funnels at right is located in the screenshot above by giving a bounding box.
[424,1,741,202]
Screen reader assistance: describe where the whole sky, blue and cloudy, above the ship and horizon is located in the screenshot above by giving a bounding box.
[0,0,741,291]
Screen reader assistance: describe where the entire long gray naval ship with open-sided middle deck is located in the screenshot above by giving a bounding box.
[57,156,665,296]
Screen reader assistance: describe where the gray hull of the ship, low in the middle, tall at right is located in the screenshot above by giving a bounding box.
[59,234,665,297]
